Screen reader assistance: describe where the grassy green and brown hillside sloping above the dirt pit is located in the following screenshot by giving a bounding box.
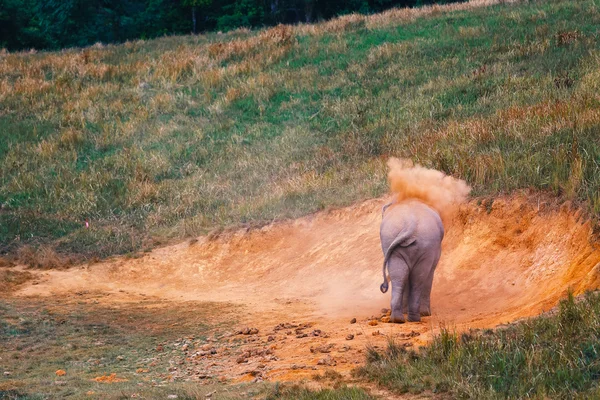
[0,0,600,265]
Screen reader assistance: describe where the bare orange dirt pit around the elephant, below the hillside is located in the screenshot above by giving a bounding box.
[8,196,600,382]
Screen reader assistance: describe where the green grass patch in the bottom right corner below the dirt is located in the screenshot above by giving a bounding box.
[358,293,600,398]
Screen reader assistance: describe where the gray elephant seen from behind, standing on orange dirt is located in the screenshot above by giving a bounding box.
[379,199,444,323]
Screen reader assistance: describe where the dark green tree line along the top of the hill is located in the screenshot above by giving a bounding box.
[0,0,456,51]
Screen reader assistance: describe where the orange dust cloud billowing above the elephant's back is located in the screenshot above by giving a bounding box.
[387,157,471,225]
